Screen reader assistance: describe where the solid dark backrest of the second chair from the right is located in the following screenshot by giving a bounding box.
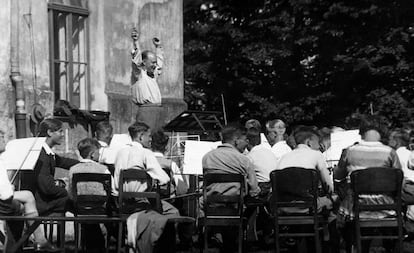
[270,167,319,214]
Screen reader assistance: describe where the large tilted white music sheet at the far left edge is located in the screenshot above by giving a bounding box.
[0,137,46,170]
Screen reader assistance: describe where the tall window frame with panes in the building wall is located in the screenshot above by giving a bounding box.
[48,3,91,110]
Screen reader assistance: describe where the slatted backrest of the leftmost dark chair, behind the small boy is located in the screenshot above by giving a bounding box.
[71,173,111,215]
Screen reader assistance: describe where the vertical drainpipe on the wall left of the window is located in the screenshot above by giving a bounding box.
[10,0,27,138]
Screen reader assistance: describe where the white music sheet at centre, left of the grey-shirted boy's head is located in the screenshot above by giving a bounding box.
[183,141,221,175]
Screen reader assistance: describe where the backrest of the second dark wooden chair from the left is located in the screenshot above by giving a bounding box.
[118,168,162,214]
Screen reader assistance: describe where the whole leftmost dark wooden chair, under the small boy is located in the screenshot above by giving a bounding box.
[72,173,112,252]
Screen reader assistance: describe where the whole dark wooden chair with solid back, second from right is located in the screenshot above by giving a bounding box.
[270,167,333,253]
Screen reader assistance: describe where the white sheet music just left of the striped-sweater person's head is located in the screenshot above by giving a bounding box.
[326,130,361,161]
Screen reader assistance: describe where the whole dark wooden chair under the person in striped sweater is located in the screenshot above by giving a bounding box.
[351,167,403,253]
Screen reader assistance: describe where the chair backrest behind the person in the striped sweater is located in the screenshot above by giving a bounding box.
[351,167,403,212]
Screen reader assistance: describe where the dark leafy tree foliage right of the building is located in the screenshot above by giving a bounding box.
[184,0,414,127]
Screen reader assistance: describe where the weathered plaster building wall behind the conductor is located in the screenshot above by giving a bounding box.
[0,0,186,151]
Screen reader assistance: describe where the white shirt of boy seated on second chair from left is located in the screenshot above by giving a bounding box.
[114,141,170,194]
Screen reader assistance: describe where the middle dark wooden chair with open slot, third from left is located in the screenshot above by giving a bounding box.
[202,173,245,252]
